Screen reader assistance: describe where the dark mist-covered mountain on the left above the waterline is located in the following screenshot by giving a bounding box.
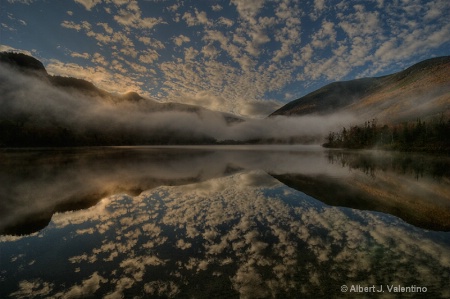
[0,52,243,147]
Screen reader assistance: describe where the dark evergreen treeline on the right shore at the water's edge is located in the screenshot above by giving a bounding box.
[323,115,450,153]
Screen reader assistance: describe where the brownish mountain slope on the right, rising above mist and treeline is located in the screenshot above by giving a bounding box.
[270,56,450,123]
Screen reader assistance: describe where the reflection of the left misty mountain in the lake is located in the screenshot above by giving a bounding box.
[0,148,236,234]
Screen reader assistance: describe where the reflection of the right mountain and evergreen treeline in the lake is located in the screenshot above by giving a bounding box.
[273,150,450,231]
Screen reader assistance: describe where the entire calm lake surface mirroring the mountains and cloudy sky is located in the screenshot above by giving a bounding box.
[0,145,450,298]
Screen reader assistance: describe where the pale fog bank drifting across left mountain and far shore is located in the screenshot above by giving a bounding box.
[0,66,355,142]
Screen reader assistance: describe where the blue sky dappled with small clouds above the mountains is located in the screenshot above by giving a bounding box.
[0,0,450,118]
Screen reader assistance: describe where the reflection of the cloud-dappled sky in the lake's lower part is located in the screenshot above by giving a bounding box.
[0,170,450,298]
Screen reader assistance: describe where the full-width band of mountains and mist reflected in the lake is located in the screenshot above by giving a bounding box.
[0,146,450,235]
